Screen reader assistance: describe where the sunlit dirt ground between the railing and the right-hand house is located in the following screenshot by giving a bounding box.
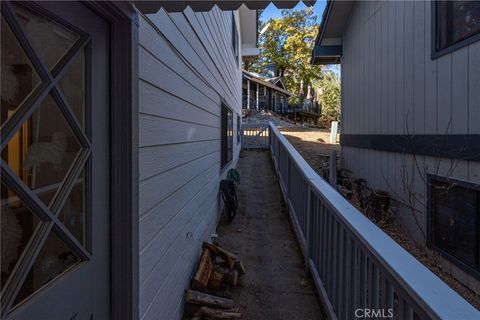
[280,127,340,175]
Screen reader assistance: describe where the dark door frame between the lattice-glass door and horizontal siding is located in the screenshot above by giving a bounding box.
[85,1,139,320]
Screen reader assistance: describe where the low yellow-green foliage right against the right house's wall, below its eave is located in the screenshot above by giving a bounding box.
[313,71,341,123]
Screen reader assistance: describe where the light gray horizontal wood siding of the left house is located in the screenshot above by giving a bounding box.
[139,7,241,319]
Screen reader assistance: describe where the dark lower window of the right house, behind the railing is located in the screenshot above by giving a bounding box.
[429,177,480,272]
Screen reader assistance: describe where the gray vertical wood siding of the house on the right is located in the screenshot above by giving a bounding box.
[341,1,480,291]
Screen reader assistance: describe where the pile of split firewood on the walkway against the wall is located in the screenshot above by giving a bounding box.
[185,242,245,320]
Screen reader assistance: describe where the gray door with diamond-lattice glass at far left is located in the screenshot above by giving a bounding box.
[0,2,110,320]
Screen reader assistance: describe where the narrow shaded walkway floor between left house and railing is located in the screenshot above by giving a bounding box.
[218,151,325,320]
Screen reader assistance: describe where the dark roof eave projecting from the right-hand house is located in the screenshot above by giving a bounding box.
[310,0,355,64]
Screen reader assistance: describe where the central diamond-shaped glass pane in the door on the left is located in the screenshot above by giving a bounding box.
[2,95,82,206]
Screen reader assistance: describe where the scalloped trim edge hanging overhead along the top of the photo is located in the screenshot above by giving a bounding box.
[133,0,316,14]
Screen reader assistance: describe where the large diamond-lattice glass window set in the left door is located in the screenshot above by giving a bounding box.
[0,3,91,304]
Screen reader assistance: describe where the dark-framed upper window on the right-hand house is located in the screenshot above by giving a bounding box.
[433,1,480,57]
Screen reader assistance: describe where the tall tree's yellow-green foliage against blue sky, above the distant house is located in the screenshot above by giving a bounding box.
[248,8,322,94]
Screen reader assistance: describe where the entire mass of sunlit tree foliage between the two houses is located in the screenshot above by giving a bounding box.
[245,8,340,123]
